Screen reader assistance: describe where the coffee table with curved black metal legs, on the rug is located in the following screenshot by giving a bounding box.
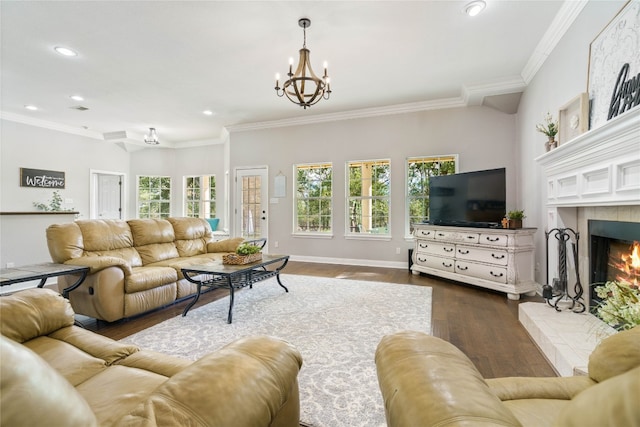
[182,254,289,323]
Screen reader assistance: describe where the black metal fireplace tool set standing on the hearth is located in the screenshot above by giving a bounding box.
[542,228,586,313]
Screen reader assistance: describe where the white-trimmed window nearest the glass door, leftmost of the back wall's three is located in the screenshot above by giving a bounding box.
[294,163,333,233]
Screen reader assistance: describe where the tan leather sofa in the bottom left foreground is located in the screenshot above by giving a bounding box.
[0,289,302,427]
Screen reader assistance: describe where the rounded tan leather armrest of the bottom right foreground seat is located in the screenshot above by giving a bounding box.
[375,331,520,427]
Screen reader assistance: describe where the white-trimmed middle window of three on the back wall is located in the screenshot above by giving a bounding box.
[346,160,391,235]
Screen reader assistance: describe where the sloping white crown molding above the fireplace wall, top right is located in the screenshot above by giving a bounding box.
[521,0,589,84]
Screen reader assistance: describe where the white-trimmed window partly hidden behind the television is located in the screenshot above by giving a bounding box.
[406,155,458,234]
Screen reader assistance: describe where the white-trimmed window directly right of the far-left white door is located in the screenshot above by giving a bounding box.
[136,176,171,218]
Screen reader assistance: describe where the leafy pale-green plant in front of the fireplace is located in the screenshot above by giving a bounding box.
[593,281,640,331]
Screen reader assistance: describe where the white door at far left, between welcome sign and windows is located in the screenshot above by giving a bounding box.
[91,172,124,219]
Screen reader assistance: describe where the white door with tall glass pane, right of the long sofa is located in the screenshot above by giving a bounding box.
[234,167,269,250]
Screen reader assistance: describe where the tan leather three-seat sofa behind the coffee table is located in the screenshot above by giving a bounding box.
[46,218,242,322]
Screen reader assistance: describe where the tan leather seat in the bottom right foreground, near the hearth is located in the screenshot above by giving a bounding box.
[376,327,640,427]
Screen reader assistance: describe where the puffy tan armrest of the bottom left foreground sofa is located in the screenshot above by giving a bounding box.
[118,336,302,427]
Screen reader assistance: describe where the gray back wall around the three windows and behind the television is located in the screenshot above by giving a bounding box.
[230,106,517,266]
